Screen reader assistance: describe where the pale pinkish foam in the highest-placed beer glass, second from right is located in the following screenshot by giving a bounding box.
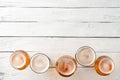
[76,46,95,66]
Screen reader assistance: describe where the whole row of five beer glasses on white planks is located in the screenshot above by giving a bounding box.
[10,46,114,77]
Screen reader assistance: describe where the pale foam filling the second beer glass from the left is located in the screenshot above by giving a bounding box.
[31,54,49,73]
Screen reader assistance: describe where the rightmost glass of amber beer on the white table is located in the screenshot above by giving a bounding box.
[94,56,114,76]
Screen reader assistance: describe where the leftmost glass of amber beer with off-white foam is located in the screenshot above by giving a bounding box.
[10,50,30,70]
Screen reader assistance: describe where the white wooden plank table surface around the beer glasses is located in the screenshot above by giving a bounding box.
[0,0,120,80]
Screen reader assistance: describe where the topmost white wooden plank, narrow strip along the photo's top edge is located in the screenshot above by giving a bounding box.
[0,0,120,7]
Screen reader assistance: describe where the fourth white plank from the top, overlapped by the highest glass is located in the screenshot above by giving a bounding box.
[0,37,120,54]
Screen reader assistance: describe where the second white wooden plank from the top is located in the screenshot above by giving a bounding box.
[0,8,120,24]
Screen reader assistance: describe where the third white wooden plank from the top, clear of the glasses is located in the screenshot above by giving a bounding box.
[0,22,120,37]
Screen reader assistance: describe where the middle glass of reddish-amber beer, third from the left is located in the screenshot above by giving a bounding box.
[56,55,77,77]
